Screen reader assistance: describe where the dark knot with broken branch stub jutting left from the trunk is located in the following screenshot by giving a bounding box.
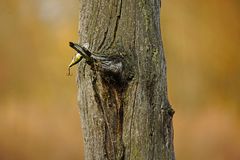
[69,42,134,87]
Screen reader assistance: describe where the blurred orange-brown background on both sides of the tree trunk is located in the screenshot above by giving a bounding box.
[0,0,240,160]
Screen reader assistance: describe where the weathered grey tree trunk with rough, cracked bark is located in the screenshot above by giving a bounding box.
[78,0,175,160]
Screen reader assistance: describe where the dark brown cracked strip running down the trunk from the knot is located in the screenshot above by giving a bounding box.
[90,54,127,160]
